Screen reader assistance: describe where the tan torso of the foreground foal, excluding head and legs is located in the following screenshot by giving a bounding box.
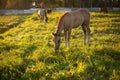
[58,8,90,28]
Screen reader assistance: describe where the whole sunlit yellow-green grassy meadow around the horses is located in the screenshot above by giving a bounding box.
[0,12,120,80]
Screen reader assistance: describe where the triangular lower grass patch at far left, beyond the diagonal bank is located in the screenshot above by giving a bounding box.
[0,15,28,34]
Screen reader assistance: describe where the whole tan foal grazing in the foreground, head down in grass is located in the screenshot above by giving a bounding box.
[52,8,90,50]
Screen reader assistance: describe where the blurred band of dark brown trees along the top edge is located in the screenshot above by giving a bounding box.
[0,0,120,9]
